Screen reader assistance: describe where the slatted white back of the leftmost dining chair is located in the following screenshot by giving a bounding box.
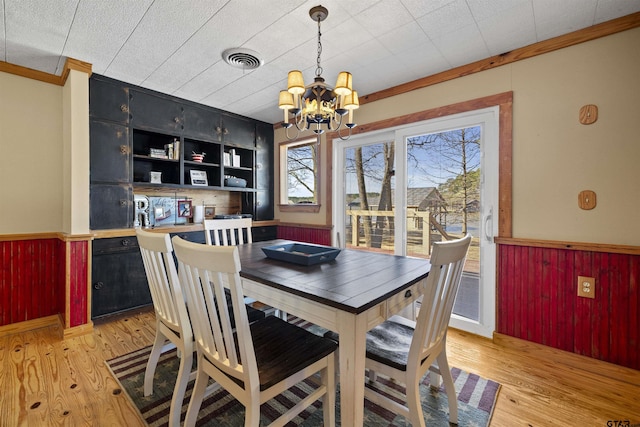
[136,229,191,334]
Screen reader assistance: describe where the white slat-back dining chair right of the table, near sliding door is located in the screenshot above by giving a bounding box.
[342,235,471,427]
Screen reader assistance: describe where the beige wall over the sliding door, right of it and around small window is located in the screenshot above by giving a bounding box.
[275,28,640,246]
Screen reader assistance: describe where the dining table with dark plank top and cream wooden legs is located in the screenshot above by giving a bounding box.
[238,240,430,426]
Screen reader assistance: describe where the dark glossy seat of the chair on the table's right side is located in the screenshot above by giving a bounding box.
[324,316,415,371]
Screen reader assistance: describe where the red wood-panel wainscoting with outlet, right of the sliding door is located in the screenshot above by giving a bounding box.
[496,245,640,369]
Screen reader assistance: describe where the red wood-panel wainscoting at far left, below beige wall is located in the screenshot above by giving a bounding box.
[0,239,65,326]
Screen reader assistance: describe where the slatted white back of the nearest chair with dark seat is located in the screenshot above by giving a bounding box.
[172,236,259,389]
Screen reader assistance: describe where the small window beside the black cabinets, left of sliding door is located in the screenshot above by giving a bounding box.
[280,140,320,212]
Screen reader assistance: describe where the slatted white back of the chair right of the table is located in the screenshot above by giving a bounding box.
[409,234,471,360]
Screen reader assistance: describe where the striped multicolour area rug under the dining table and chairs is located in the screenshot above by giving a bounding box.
[107,318,500,427]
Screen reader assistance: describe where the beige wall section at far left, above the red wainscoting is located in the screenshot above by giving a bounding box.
[0,72,63,234]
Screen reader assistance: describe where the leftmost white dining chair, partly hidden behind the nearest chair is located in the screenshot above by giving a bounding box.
[136,228,195,426]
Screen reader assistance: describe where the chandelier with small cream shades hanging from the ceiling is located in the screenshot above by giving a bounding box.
[278,6,360,140]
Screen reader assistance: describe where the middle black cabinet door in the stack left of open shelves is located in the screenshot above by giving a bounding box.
[89,120,131,183]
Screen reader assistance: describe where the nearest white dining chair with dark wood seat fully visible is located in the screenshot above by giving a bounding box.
[172,236,337,427]
